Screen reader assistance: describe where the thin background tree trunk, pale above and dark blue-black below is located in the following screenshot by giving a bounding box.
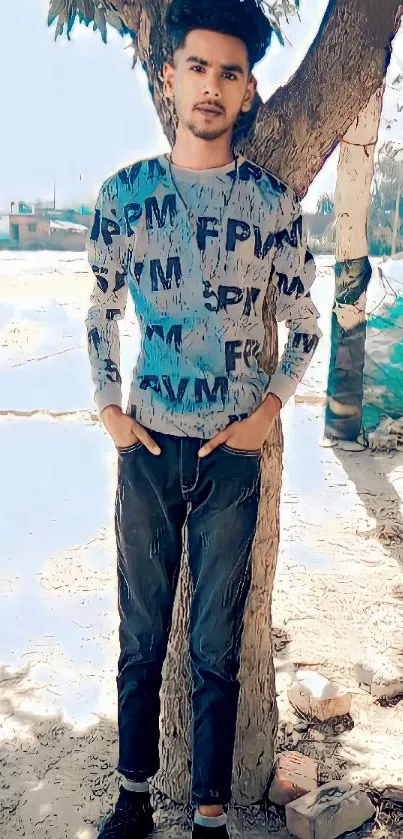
[325,90,384,445]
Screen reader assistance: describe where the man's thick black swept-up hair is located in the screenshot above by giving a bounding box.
[165,0,273,68]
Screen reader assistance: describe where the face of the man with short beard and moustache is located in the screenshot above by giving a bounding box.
[163,30,256,140]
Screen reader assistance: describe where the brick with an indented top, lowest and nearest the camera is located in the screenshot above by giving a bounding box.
[285,781,375,839]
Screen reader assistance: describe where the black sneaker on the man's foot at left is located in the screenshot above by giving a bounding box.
[98,786,155,839]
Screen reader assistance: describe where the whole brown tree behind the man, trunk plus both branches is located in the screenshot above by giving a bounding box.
[48,0,403,804]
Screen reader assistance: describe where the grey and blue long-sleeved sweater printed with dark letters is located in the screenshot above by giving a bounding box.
[86,155,321,438]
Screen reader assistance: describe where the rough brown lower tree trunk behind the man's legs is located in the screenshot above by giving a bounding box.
[155,284,282,805]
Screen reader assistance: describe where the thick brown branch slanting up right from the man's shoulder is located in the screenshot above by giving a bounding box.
[245,0,403,197]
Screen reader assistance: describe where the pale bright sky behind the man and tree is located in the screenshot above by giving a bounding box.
[0,0,400,211]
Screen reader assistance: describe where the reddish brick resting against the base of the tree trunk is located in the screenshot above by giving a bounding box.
[269,751,318,807]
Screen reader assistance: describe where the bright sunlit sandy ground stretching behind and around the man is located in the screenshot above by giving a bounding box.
[0,252,403,839]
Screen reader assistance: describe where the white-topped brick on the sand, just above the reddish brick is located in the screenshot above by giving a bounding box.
[288,670,351,721]
